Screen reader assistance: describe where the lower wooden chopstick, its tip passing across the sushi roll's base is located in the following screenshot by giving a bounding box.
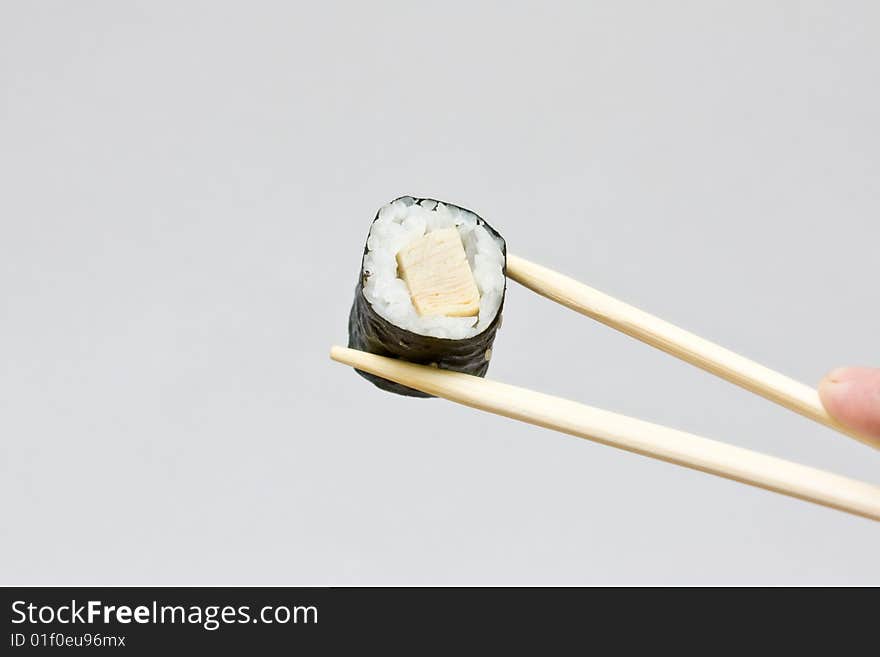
[330,347,880,520]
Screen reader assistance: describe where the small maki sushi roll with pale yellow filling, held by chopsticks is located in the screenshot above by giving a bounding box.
[348,196,507,397]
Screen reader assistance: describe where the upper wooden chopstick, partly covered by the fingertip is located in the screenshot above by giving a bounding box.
[507,254,877,448]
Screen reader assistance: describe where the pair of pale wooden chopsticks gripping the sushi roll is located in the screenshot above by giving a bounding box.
[330,255,880,520]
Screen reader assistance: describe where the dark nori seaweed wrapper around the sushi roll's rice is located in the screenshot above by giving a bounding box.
[348,196,507,397]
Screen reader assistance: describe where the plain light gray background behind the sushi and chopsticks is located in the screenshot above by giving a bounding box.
[0,2,880,584]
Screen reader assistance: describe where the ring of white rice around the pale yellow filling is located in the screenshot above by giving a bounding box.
[364,197,504,340]
